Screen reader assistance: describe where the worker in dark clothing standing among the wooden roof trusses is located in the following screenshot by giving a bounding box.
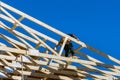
[59,34,79,57]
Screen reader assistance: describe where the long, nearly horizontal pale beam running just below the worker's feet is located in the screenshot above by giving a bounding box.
[0,46,120,69]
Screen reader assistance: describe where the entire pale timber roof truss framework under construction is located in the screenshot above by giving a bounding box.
[0,2,120,80]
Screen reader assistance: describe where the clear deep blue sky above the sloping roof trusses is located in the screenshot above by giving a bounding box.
[2,0,120,59]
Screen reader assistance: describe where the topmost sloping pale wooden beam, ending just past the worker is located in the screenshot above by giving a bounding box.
[1,2,86,47]
